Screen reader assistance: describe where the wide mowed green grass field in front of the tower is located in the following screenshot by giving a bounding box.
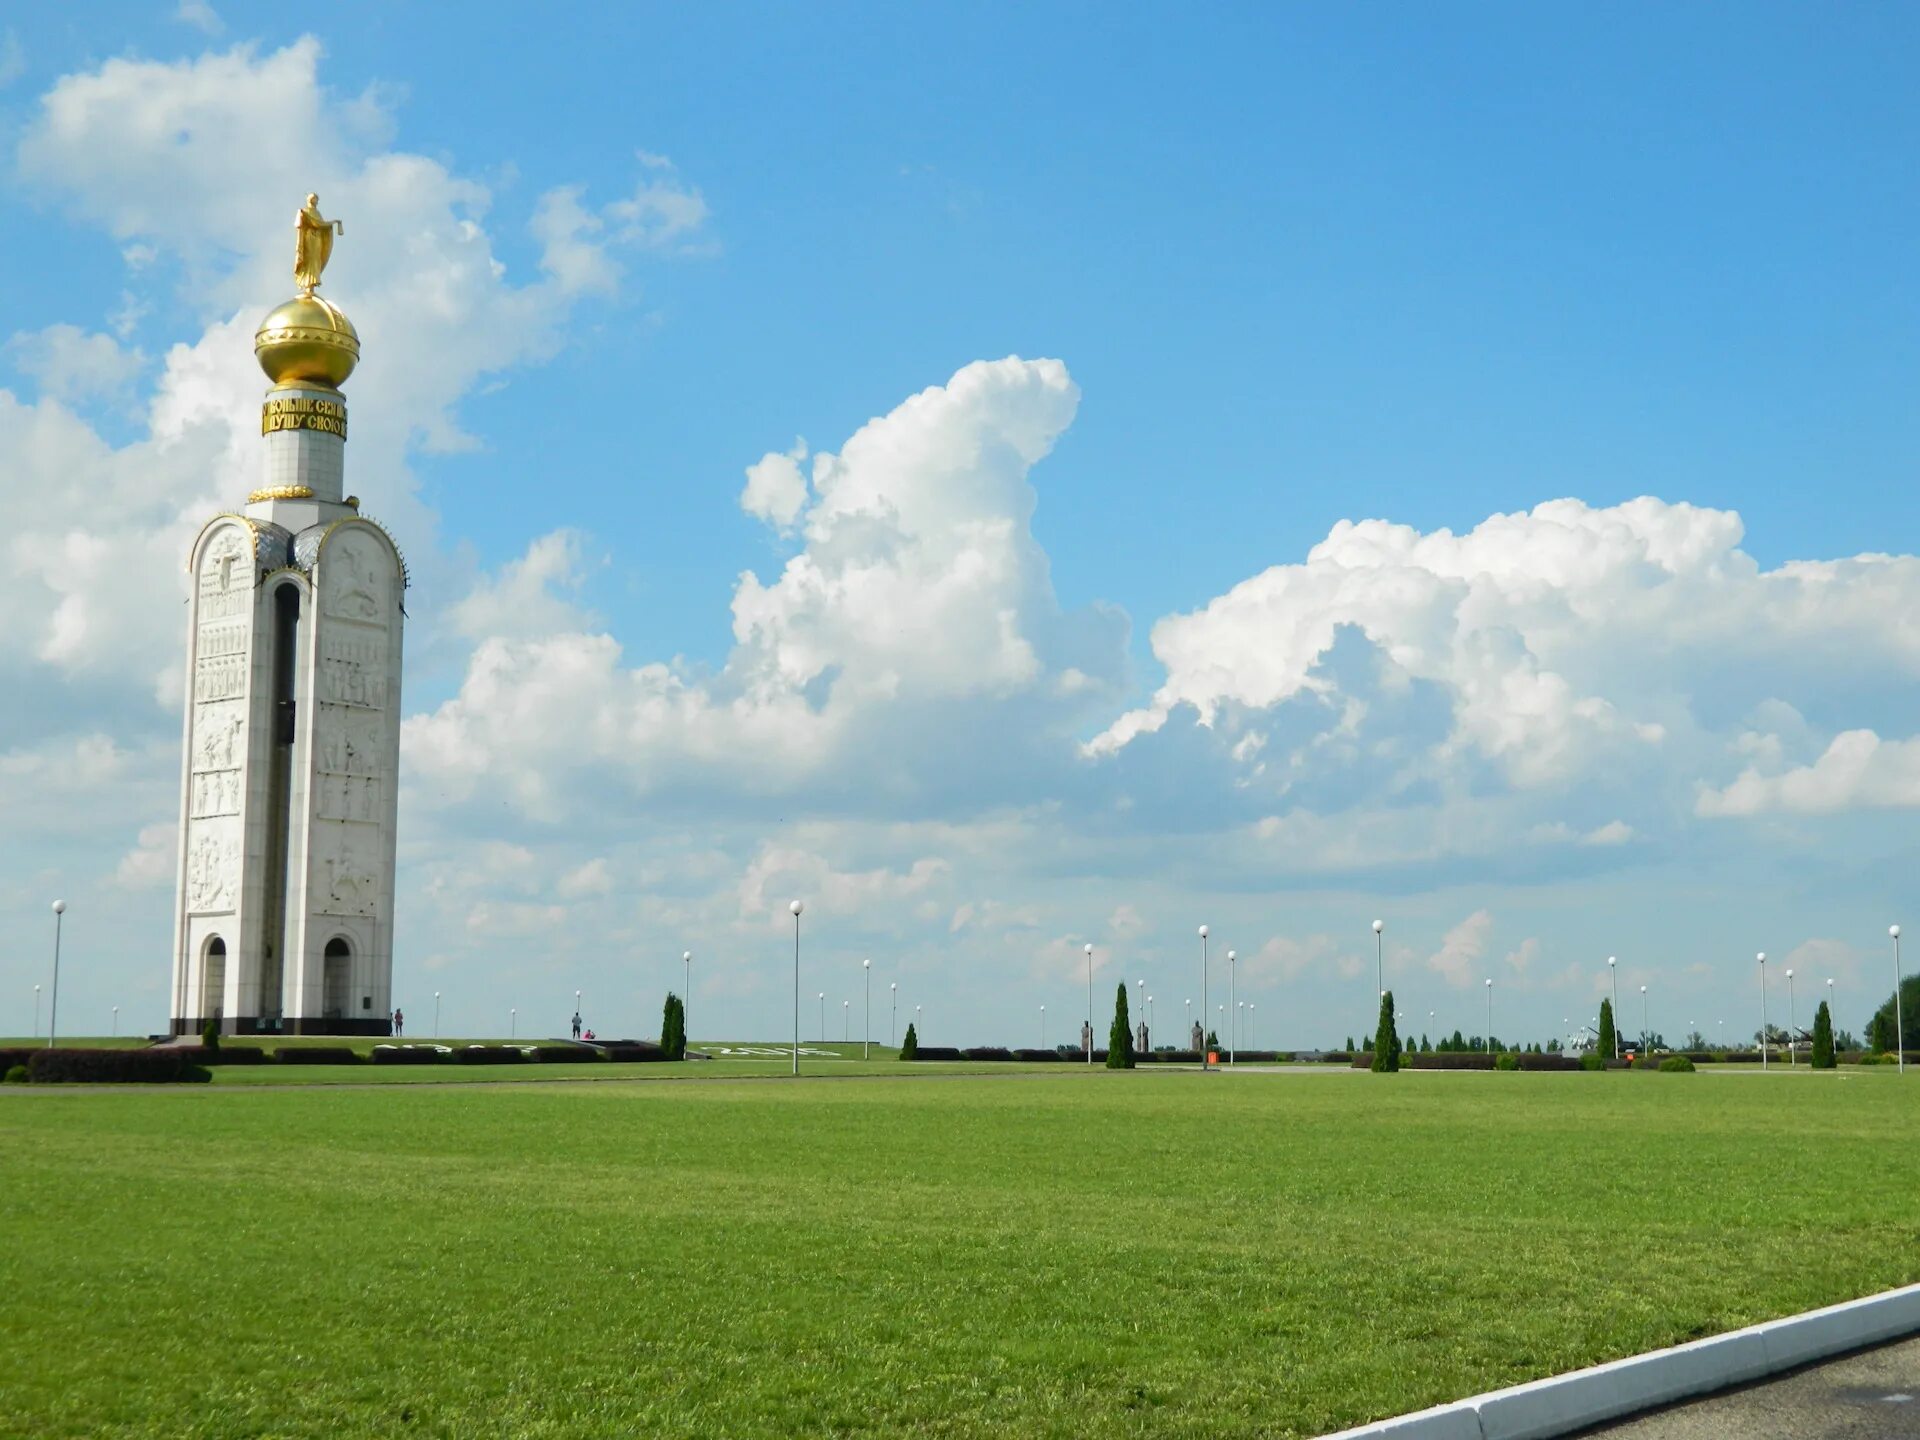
[0,1066,1920,1440]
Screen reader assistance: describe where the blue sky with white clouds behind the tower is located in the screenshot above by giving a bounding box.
[0,4,1920,1044]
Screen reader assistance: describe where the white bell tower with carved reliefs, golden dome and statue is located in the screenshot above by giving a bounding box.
[171,196,407,1035]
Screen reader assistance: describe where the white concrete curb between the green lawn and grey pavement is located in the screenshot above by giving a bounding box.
[1325,1284,1920,1440]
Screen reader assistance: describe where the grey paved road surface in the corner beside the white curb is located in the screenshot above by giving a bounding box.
[1586,1336,1920,1440]
